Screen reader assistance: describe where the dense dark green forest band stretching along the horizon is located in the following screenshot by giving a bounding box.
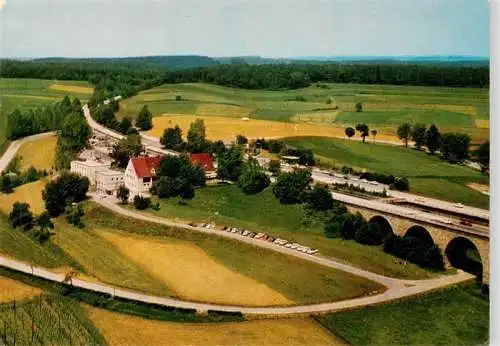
[1,60,489,99]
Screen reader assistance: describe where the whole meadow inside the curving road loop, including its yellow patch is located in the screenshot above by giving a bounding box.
[0,202,383,306]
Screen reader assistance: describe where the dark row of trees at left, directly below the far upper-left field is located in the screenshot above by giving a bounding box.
[7,96,83,140]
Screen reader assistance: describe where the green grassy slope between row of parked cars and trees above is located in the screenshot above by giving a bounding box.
[142,186,433,279]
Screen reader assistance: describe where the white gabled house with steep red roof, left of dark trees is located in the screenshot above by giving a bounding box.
[125,156,162,199]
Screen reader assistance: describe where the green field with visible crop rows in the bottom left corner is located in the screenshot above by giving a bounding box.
[0,296,106,345]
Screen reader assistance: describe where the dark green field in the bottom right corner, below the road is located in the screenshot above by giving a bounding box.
[316,285,489,345]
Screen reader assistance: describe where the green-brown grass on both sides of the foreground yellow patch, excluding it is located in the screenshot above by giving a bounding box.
[0,203,381,303]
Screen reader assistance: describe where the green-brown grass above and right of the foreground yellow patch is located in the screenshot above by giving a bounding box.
[88,204,380,303]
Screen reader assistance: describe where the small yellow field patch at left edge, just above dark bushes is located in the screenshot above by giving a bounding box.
[0,179,47,214]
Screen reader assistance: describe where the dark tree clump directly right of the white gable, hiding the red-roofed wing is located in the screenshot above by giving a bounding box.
[152,155,205,199]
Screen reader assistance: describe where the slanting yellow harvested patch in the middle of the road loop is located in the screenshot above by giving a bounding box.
[99,231,293,306]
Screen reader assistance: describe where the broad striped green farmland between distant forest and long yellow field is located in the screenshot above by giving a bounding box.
[120,83,489,143]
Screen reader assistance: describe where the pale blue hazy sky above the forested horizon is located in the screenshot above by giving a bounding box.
[0,0,489,58]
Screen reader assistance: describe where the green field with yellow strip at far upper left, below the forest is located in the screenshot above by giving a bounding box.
[0,78,92,153]
